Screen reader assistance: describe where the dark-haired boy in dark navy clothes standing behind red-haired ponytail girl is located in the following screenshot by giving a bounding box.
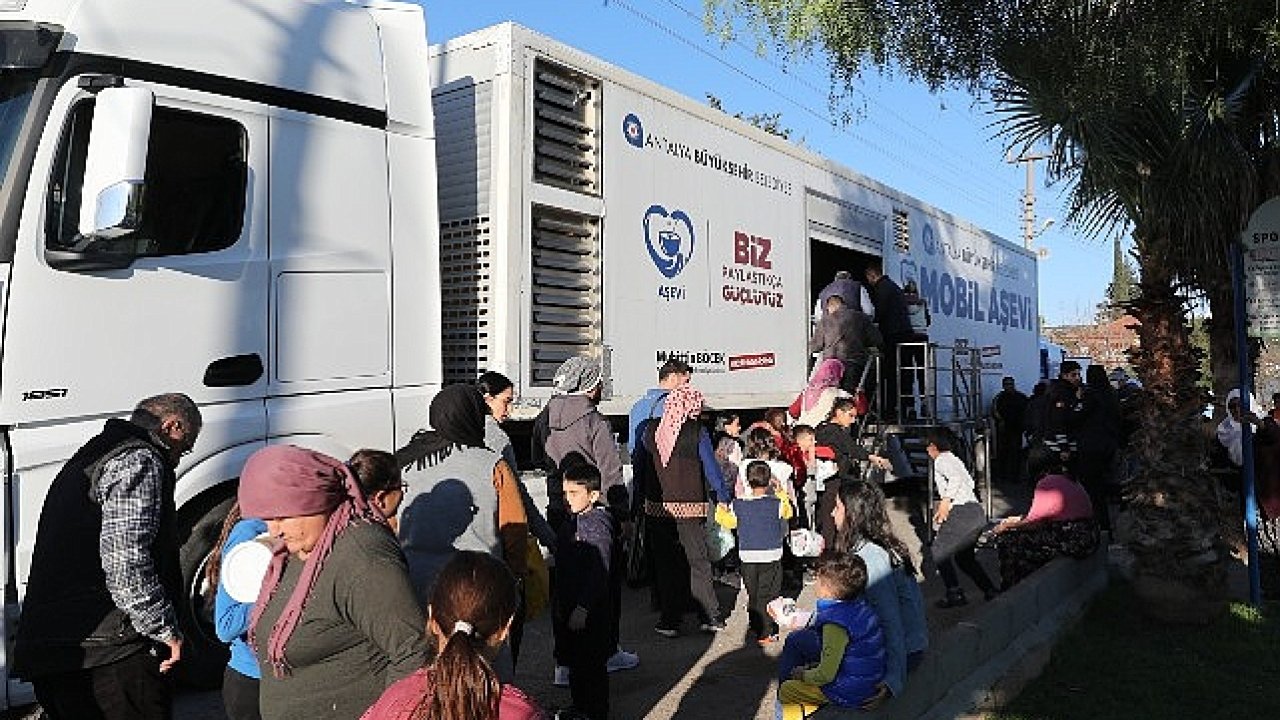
[553,462,621,720]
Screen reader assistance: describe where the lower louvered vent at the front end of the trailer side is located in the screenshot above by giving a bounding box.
[529,206,600,387]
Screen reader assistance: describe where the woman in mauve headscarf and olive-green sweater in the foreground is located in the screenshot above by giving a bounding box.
[239,445,426,720]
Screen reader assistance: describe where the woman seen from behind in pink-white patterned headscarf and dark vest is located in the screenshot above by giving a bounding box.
[632,384,732,638]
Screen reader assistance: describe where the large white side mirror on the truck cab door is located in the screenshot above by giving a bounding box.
[79,87,155,240]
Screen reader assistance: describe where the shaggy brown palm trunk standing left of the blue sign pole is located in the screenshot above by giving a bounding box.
[1117,242,1228,623]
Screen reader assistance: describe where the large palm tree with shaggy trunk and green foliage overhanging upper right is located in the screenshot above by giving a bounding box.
[707,0,1280,619]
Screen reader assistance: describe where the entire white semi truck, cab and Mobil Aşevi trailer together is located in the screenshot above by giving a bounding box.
[0,0,1037,706]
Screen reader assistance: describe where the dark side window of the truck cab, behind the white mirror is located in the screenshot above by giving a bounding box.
[45,100,248,256]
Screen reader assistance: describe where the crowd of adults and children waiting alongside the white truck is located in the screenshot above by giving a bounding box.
[14,324,1121,720]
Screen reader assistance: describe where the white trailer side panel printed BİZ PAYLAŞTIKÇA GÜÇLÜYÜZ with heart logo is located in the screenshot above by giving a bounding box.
[593,82,809,407]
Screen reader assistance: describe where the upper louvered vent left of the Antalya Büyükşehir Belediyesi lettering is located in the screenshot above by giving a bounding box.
[534,60,600,195]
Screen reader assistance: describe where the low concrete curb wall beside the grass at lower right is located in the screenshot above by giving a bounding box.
[814,548,1108,720]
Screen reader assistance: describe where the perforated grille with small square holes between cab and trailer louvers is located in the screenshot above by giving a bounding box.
[440,217,493,383]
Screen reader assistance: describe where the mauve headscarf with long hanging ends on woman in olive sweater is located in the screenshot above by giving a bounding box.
[239,445,387,678]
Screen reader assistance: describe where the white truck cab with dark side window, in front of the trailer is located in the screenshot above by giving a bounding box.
[0,0,440,706]
